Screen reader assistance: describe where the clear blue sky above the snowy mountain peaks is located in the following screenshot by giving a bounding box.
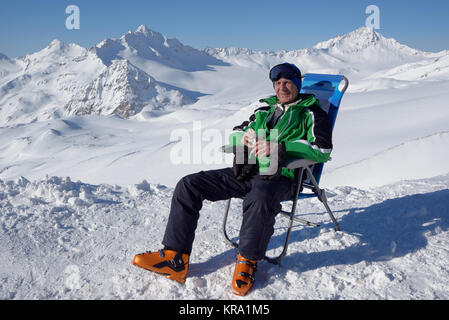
[0,0,449,58]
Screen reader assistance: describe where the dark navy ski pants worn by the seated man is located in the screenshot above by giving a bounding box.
[162,168,293,260]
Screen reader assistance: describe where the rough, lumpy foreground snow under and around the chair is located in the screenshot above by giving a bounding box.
[0,175,449,299]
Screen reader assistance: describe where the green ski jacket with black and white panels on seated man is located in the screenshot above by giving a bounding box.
[229,94,332,179]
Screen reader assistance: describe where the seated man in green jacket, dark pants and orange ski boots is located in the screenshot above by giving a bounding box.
[133,63,332,296]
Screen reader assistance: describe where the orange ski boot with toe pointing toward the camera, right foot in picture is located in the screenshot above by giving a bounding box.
[232,253,257,296]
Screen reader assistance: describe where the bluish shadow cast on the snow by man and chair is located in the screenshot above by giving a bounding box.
[191,190,449,287]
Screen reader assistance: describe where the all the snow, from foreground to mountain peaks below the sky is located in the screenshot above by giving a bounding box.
[0,26,449,300]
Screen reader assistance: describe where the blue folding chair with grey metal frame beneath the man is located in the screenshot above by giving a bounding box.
[222,73,349,264]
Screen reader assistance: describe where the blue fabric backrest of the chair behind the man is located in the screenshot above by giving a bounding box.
[301,73,349,188]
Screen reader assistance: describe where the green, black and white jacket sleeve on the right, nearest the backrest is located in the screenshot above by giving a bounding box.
[285,105,332,162]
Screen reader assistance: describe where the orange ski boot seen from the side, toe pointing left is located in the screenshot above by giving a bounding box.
[132,250,189,283]
